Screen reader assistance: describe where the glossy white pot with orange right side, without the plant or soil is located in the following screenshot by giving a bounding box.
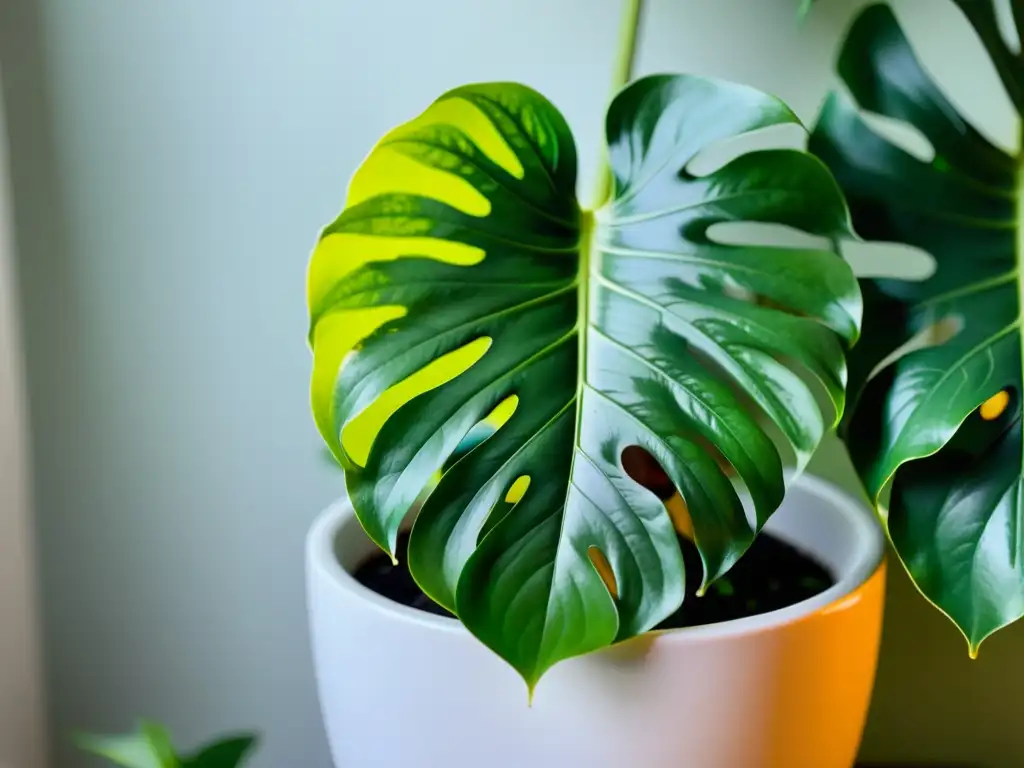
[307,477,885,768]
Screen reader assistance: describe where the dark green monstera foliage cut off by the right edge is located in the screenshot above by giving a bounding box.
[811,0,1024,655]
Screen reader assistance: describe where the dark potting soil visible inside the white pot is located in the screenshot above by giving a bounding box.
[354,532,836,630]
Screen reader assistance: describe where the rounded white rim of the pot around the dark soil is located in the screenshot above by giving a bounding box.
[306,474,886,644]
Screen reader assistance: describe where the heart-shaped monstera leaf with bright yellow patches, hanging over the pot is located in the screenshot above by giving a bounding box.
[309,77,860,687]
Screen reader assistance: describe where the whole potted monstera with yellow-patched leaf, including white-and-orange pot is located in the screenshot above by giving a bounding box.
[308,0,883,768]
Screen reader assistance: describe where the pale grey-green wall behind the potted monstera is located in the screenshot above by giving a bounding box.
[0,0,1024,768]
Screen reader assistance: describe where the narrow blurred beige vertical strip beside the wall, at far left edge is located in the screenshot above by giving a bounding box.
[0,73,45,768]
